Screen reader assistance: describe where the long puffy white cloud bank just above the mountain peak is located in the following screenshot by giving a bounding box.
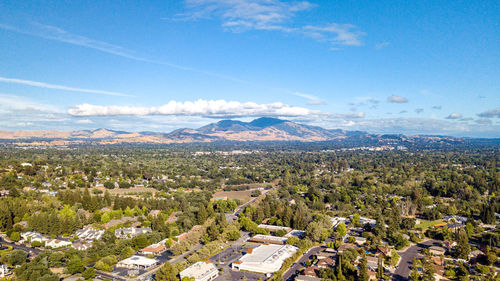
[68,99,318,118]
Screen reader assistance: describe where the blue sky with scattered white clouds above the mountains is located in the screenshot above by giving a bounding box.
[0,0,500,137]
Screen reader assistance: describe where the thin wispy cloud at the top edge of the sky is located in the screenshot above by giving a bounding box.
[177,0,365,46]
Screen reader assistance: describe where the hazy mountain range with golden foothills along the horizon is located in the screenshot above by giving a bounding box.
[0,117,486,145]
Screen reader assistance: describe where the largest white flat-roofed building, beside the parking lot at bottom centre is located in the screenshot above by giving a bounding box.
[232,245,298,274]
